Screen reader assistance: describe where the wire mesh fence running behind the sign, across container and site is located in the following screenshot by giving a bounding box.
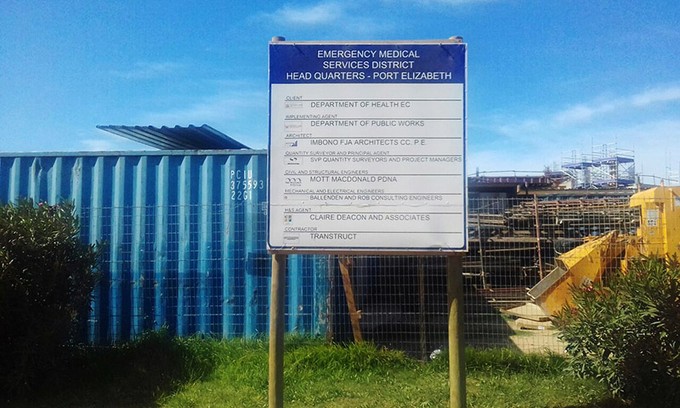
[71,193,652,358]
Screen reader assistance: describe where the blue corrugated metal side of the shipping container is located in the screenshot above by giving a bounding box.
[0,151,330,343]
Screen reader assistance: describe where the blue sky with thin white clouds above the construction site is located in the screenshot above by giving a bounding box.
[0,0,680,180]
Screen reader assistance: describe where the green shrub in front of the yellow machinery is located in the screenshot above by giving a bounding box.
[557,258,680,407]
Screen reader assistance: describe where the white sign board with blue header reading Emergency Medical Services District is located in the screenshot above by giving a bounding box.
[268,41,467,252]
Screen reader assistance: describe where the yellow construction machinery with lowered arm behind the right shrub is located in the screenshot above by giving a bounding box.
[529,186,680,316]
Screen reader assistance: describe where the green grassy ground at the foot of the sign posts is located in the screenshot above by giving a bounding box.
[0,334,627,408]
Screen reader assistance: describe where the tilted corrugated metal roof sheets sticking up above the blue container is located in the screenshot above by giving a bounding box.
[97,124,248,150]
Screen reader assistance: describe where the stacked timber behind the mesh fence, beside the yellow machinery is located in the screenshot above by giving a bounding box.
[463,197,639,289]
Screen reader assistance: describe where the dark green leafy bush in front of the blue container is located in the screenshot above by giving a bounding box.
[0,200,97,392]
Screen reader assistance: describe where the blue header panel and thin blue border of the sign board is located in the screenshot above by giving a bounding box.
[267,42,469,253]
